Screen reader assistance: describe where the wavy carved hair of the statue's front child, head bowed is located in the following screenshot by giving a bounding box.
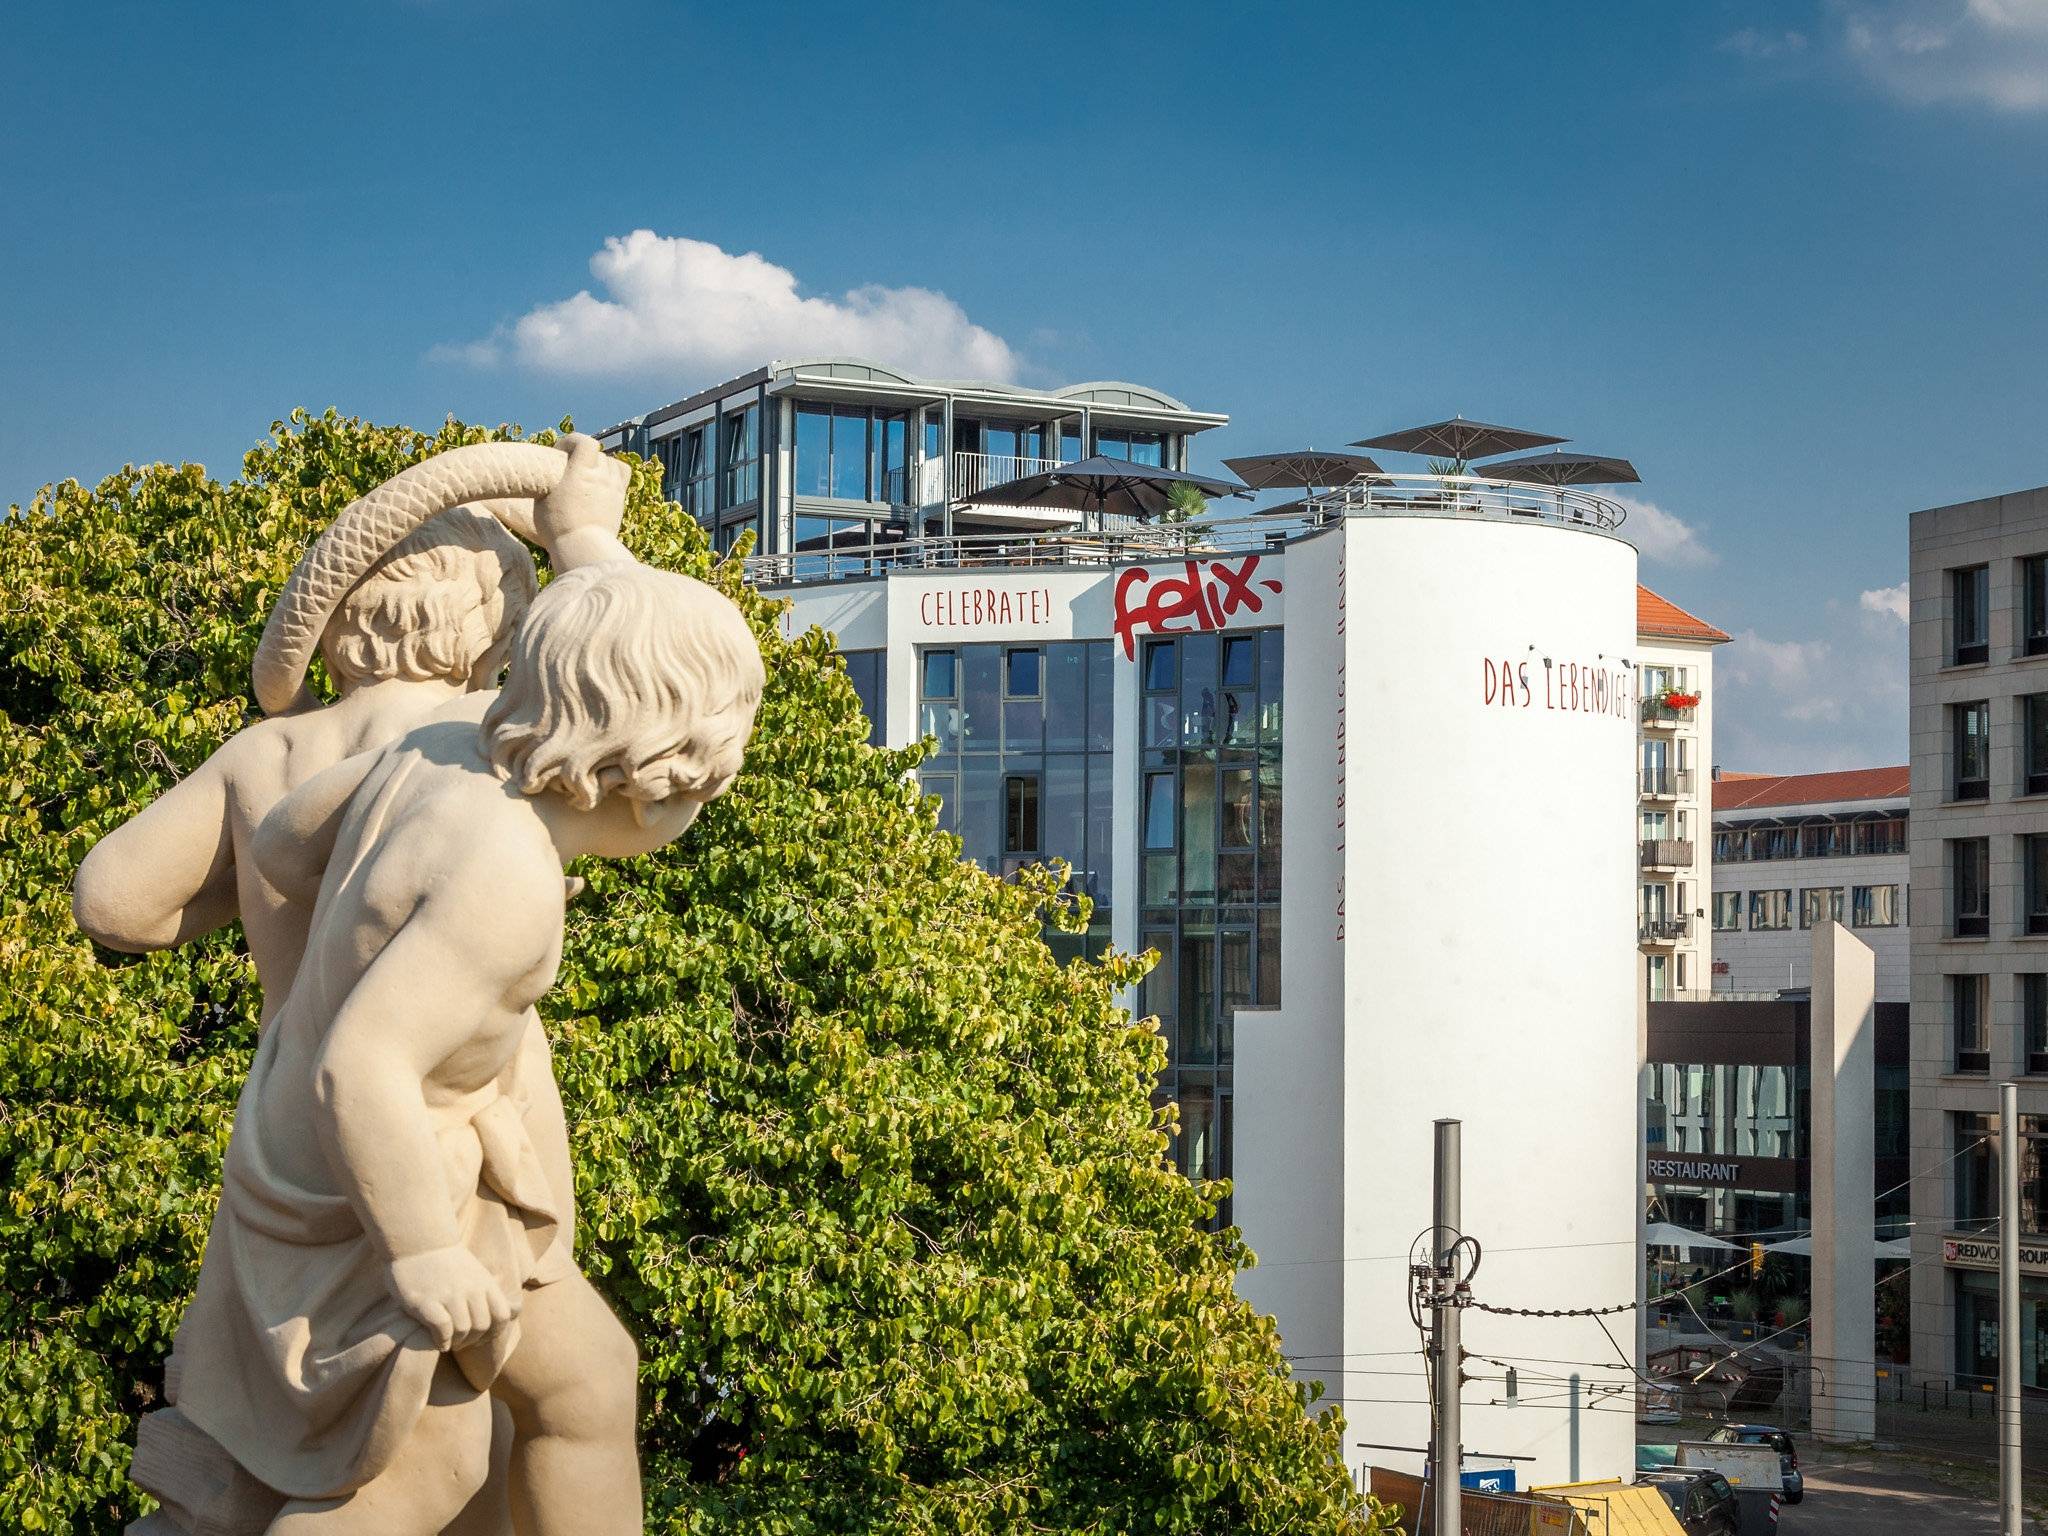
[481,561,766,811]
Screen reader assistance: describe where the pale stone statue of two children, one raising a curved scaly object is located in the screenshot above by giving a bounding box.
[78,438,762,1536]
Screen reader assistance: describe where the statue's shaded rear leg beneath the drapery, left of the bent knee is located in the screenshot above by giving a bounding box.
[270,1356,492,1536]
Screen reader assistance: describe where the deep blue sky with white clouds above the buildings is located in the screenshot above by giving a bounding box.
[0,0,2048,770]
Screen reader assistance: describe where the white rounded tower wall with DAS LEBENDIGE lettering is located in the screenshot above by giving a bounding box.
[1237,508,1640,1487]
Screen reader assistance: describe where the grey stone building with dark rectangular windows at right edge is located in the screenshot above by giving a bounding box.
[1911,487,2048,1389]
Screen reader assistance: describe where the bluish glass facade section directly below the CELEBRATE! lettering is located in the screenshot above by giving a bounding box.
[918,641,1116,948]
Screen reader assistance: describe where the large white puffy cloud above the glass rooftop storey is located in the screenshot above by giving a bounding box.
[446,229,1018,381]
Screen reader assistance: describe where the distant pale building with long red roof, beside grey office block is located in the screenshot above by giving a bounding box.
[1710,764,1913,1004]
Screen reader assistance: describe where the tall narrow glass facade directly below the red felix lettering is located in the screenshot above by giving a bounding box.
[1139,629,1284,1221]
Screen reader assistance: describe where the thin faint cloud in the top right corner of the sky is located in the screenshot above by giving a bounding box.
[1835,0,2048,113]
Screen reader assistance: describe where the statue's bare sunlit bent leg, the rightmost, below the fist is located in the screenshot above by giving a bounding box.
[492,1274,643,1536]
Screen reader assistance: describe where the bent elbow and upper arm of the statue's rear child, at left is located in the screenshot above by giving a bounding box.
[72,737,244,954]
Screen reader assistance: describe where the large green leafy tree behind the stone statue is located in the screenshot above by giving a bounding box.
[0,412,1382,1536]
